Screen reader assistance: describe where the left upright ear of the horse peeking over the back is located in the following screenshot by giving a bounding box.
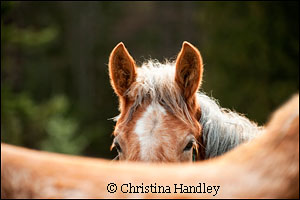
[109,42,136,96]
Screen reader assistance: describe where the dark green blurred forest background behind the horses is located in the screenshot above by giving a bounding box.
[1,1,299,158]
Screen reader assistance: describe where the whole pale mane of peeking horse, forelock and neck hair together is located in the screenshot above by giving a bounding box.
[115,60,261,158]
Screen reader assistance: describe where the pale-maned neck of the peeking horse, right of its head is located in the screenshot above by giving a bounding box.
[197,93,262,159]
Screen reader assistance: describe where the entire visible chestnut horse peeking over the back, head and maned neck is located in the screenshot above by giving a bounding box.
[108,42,263,162]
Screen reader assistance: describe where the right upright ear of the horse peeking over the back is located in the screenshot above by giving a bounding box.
[175,42,203,100]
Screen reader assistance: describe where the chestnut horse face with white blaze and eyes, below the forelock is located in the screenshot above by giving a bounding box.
[113,103,199,162]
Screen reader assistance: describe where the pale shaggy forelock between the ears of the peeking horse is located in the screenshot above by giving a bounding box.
[120,60,199,126]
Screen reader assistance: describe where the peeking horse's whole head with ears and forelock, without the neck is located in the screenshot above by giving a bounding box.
[109,42,203,162]
